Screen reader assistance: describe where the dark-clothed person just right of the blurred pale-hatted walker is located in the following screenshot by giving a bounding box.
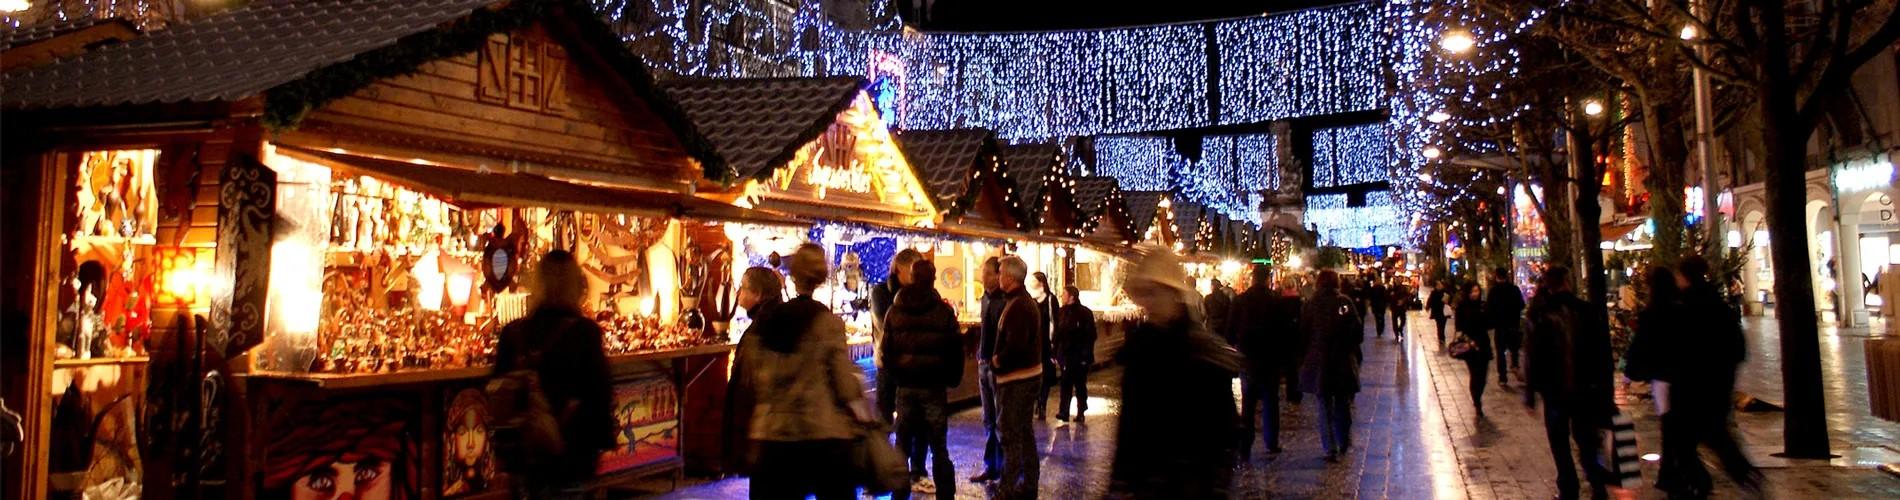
[1227,264,1300,460]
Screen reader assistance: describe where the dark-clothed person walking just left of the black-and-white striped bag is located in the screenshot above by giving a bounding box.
[1524,266,1615,498]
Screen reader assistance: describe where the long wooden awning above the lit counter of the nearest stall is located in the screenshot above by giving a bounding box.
[277,146,811,226]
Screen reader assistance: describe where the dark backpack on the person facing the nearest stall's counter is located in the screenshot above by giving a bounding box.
[485,317,576,473]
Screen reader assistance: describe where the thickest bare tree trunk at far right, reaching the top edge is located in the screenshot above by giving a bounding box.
[1758,2,1830,458]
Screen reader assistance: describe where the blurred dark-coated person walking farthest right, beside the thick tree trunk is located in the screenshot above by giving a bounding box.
[1625,257,1761,498]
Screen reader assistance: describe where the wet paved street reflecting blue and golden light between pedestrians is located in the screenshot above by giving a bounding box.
[659,311,1900,498]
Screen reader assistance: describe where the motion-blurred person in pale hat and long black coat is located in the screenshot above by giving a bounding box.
[1110,251,1243,498]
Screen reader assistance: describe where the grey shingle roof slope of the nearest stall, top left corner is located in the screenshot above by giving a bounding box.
[0,0,496,108]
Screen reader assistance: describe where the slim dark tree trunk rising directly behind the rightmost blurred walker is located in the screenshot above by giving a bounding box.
[1644,101,1689,266]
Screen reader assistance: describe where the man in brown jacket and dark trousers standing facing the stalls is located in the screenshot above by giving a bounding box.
[990,255,1047,500]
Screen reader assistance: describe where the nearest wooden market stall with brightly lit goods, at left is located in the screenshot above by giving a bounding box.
[0,2,763,498]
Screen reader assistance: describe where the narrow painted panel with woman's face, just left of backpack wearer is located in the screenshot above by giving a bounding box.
[443,388,505,496]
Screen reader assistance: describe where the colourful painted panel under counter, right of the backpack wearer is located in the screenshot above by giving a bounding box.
[600,375,680,473]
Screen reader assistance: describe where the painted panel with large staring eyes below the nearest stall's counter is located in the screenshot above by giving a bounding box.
[260,397,422,500]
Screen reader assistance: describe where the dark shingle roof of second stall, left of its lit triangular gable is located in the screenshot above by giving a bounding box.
[661,76,865,179]
